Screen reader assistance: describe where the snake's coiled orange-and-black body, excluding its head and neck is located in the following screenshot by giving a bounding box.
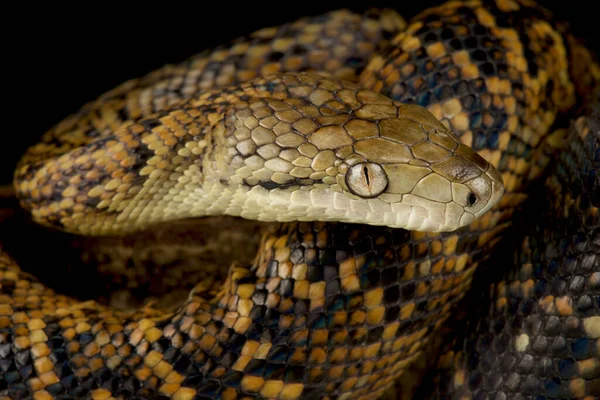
[0,0,600,400]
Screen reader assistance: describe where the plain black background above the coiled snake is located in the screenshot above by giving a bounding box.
[0,0,600,184]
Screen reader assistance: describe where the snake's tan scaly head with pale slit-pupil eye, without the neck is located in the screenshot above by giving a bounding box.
[219,74,504,232]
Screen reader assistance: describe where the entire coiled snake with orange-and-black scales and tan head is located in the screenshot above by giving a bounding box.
[0,0,600,400]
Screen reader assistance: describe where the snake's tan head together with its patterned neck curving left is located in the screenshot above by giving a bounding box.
[15,73,504,234]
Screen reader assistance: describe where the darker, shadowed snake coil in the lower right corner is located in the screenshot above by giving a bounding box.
[426,95,600,400]
